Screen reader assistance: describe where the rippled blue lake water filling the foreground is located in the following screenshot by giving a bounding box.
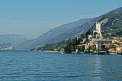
[0,51,122,81]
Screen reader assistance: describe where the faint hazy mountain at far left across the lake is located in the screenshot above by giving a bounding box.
[0,34,27,47]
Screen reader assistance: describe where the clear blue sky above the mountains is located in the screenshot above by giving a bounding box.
[0,0,122,39]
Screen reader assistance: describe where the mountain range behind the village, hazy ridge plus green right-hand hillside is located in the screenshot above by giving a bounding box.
[15,7,122,49]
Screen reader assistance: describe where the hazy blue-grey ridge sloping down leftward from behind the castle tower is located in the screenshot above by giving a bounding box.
[18,17,100,49]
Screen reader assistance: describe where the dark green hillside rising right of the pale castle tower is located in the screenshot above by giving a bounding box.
[100,7,122,37]
